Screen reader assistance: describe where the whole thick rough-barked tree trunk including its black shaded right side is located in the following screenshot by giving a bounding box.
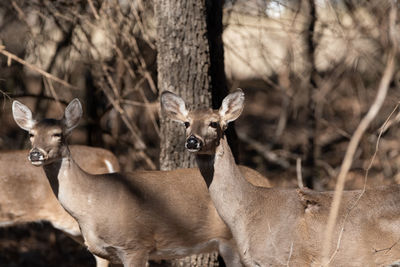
[154,0,227,266]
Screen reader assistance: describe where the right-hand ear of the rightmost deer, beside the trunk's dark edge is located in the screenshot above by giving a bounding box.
[218,88,244,124]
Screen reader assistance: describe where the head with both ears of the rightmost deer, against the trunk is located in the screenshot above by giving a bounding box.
[161,89,244,154]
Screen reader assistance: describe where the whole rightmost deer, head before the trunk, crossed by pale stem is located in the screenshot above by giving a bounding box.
[160,89,400,266]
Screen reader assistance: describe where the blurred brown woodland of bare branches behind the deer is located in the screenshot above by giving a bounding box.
[0,0,400,266]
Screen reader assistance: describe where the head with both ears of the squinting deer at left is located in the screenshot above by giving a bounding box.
[12,98,82,166]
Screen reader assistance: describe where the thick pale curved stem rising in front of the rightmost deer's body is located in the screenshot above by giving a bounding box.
[321,4,397,266]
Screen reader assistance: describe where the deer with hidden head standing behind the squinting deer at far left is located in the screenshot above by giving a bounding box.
[0,145,120,267]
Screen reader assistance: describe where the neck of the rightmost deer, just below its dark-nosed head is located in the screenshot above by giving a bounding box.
[196,137,252,226]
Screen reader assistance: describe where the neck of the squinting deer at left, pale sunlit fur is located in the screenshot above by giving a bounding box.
[43,146,90,219]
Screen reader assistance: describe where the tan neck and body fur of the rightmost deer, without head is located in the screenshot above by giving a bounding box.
[216,139,400,266]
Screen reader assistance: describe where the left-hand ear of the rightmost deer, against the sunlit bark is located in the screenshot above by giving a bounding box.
[160,91,189,122]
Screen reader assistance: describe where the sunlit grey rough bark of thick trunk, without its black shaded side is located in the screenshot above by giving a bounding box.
[155,0,211,170]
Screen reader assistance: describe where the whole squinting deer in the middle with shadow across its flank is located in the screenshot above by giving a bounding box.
[12,99,269,266]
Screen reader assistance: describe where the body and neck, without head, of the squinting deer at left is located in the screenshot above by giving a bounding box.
[43,150,268,266]
